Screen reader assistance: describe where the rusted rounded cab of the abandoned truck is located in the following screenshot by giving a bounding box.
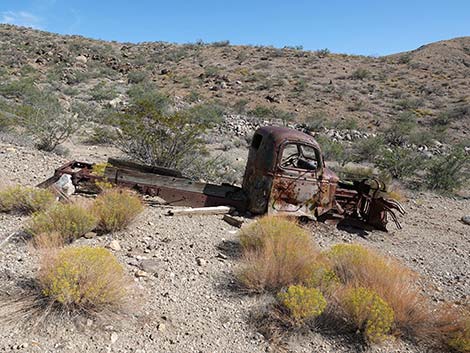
[242,126,339,219]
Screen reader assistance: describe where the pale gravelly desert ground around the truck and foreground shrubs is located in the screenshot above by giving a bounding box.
[0,139,470,353]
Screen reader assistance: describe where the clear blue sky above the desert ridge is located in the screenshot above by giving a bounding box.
[0,0,470,55]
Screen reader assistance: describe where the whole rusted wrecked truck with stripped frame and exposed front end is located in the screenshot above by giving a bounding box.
[39,127,404,230]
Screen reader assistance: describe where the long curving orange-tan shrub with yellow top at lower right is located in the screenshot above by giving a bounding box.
[326,244,431,337]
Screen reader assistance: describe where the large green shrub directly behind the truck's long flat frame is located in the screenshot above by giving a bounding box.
[117,92,207,171]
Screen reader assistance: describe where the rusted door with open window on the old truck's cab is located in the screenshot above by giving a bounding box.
[268,142,322,217]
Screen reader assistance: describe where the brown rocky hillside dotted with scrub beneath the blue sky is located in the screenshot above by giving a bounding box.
[0,25,470,139]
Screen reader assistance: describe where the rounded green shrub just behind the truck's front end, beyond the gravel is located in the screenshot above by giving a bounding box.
[375,146,422,180]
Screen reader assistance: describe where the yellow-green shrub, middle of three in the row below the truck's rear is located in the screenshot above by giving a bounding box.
[26,203,98,242]
